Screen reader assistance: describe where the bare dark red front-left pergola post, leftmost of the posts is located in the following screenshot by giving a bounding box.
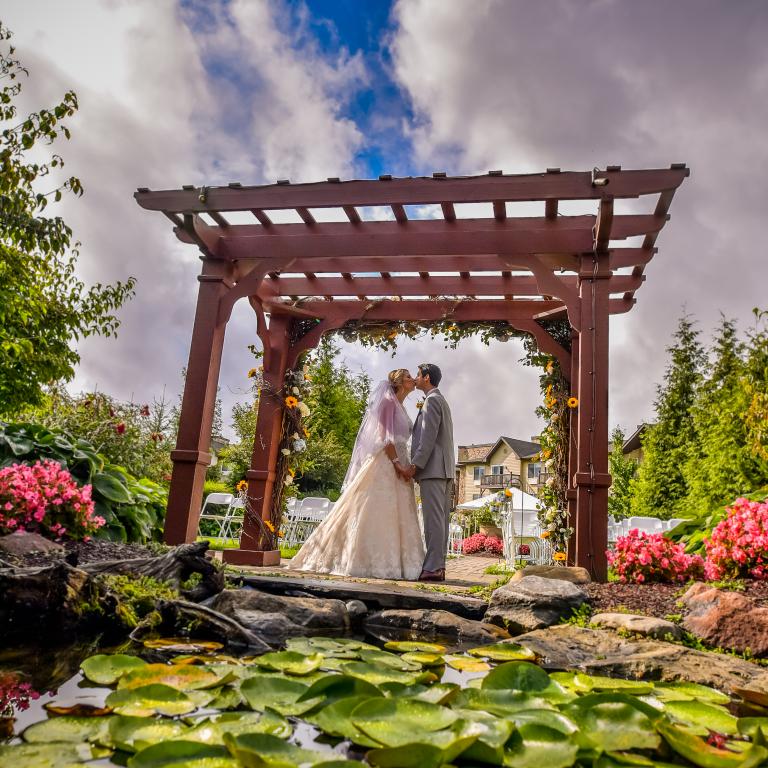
[164,260,232,544]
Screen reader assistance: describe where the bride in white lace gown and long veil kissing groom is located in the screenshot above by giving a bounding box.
[290,368,424,580]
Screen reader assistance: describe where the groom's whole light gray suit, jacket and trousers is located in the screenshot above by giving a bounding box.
[411,388,456,571]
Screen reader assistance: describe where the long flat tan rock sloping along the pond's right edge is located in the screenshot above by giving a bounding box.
[515,624,768,693]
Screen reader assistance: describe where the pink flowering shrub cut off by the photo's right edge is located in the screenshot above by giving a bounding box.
[704,498,768,579]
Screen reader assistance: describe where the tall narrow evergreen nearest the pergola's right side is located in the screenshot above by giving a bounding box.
[632,315,704,518]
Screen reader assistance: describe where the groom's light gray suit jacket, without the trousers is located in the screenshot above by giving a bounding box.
[411,387,456,480]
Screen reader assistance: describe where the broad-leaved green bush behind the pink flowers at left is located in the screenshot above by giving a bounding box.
[0,421,168,543]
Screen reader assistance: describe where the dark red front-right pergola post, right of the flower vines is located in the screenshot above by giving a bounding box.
[573,251,611,581]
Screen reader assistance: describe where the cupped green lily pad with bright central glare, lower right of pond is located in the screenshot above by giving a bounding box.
[563,693,661,752]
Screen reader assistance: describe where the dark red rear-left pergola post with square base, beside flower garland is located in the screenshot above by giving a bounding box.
[224,315,291,565]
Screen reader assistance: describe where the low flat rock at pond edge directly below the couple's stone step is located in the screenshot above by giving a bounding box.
[363,608,509,642]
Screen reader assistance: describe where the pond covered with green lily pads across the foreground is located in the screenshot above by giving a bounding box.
[0,637,768,768]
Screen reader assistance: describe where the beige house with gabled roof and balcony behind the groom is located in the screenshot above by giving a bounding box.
[456,437,543,504]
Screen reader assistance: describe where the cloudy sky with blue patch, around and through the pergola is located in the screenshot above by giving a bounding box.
[6,0,768,444]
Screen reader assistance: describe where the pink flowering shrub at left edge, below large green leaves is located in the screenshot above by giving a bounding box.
[0,459,105,539]
